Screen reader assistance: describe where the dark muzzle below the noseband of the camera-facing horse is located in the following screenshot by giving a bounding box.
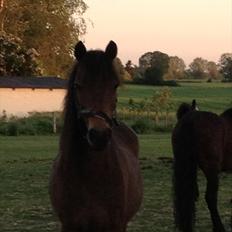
[87,128,112,151]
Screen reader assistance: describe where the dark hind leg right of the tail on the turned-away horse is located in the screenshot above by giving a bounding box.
[205,173,225,232]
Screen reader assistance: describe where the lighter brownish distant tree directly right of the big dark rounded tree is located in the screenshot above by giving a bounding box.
[164,56,186,80]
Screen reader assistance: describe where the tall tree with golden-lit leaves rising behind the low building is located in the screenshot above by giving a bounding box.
[3,0,87,76]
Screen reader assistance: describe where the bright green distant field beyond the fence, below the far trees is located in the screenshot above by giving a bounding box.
[119,82,232,113]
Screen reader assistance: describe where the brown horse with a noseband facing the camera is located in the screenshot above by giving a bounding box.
[50,41,143,232]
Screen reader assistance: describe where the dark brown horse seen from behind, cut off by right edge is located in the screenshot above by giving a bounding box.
[172,100,232,232]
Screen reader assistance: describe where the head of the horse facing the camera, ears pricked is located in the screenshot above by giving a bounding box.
[72,41,120,150]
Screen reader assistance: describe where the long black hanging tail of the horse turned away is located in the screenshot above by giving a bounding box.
[173,140,198,232]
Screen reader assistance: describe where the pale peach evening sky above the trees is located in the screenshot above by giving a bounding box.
[82,0,232,65]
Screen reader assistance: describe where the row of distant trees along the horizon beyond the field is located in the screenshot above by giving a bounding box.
[125,51,232,85]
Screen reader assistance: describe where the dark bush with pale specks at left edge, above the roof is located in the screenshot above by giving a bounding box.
[0,33,41,76]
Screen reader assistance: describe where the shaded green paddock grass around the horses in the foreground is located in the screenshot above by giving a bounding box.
[0,133,232,232]
